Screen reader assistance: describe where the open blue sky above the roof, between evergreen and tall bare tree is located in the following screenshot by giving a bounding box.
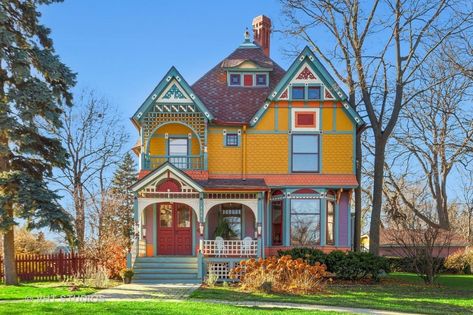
[41,0,292,145]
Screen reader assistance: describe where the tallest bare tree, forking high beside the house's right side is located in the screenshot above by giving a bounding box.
[282,0,473,254]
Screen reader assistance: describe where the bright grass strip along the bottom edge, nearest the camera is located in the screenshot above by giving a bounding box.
[0,301,346,315]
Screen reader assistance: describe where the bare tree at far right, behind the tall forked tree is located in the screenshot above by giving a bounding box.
[385,54,473,230]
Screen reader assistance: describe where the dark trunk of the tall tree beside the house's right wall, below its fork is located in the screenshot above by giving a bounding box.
[370,135,386,255]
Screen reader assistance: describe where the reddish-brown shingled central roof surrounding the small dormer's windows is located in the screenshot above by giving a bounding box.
[192,43,285,124]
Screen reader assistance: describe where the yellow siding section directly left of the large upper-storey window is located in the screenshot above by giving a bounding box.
[247,134,289,174]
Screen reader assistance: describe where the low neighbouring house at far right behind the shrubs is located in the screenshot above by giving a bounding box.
[378,228,470,257]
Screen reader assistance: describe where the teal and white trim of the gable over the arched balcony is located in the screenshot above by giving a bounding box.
[132,66,214,125]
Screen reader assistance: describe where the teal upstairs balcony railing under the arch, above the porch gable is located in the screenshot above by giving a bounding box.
[144,155,205,170]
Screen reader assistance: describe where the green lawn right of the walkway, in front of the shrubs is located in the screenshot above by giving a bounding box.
[191,273,473,315]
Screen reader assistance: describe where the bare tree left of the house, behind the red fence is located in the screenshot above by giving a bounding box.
[53,91,128,250]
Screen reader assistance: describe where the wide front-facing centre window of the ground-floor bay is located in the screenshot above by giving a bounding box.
[291,199,320,246]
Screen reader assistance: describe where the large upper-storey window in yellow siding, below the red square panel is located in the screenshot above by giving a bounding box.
[292,134,319,172]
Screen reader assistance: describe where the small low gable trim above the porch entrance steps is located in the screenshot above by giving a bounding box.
[130,162,203,192]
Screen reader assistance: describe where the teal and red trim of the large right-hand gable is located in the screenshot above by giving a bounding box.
[250,46,365,126]
